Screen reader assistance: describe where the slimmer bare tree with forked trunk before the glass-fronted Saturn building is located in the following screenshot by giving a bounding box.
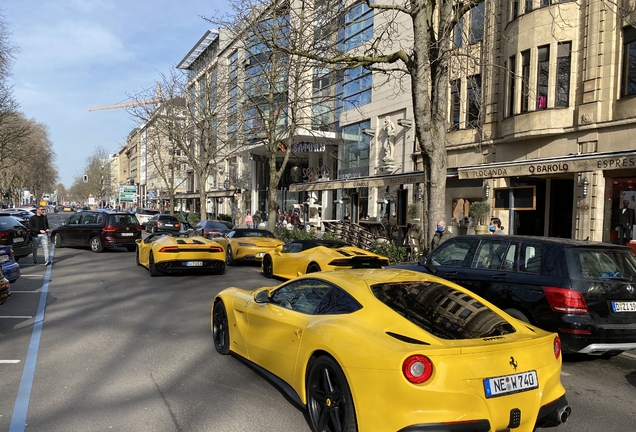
[207,1,342,230]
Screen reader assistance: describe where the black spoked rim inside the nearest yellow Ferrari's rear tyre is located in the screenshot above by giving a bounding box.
[307,365,347,431]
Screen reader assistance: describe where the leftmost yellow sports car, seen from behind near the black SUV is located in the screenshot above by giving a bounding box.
[136,232,225,276]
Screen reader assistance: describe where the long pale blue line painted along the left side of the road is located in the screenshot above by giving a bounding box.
[9,245,55,432]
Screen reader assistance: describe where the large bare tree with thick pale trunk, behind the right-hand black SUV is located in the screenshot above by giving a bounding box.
[211,0,490,242]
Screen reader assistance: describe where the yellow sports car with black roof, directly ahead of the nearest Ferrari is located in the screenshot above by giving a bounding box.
[261,240,389,279]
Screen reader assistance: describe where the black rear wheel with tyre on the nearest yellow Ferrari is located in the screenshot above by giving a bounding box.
[307,356,358,432]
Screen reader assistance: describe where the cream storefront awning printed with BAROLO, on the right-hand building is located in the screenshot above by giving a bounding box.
[457,150,636,180]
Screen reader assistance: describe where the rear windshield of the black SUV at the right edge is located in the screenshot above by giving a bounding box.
[570,248,636,282]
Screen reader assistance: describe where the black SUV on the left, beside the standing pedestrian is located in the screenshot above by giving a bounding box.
[51,210,141,252]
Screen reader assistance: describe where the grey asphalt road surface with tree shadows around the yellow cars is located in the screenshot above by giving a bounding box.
[0,215,636,432]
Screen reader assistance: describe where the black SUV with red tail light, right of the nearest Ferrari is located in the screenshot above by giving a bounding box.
[397,235,636,354]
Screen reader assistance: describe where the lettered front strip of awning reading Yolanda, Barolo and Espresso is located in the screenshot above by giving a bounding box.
[457,156,636,179]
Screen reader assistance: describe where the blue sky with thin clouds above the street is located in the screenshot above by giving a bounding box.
[0,0,230,188]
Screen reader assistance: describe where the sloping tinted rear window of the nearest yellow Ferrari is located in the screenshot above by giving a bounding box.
[371,281,516,339]
